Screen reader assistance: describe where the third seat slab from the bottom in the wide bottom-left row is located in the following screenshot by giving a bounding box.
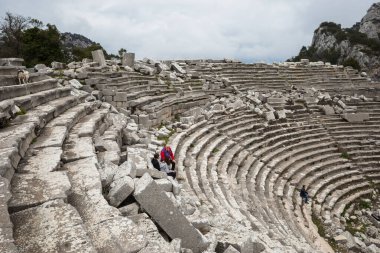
[17,147,62,174]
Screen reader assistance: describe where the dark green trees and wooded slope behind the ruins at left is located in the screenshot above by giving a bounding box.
[0,12,110,67]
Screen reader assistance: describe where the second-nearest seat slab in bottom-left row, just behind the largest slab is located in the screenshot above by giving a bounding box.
[8,171,71,212]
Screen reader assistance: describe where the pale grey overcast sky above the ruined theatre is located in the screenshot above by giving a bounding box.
[0,0,376,62]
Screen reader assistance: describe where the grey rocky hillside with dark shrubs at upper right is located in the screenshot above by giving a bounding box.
[291,3,380,78]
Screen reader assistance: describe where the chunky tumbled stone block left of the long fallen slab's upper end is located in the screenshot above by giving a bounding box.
[107,176,135,207]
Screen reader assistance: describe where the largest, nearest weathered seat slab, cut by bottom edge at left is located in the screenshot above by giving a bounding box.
[11,199,97,253]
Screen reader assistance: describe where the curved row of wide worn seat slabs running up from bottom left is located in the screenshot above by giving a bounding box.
[9,101,101,252]
